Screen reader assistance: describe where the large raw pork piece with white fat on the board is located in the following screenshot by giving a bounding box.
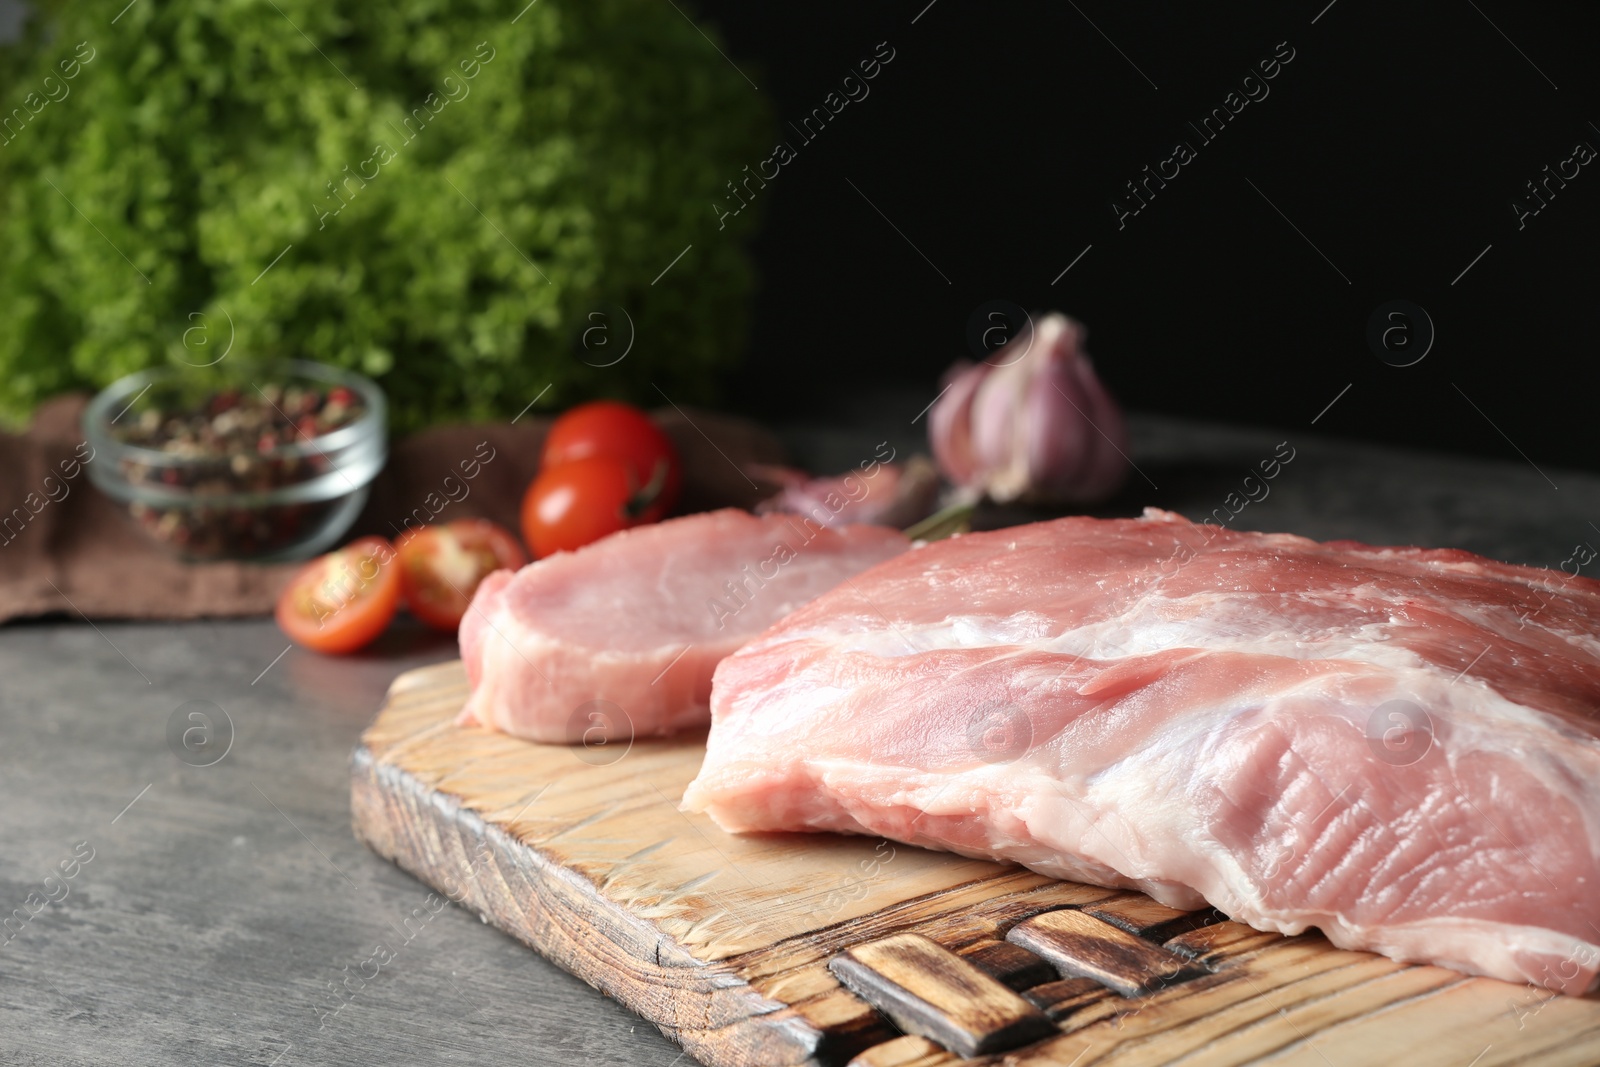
[685,509,1600,992]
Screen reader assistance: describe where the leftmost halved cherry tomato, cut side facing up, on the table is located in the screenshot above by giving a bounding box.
[277,537,400,653]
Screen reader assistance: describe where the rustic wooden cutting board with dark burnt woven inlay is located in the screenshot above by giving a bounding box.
[350,662,1600,1067]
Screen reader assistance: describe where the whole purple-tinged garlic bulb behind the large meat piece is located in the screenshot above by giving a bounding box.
[928,314,1128,504]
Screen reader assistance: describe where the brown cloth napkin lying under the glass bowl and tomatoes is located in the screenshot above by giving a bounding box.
[0,394,784,622]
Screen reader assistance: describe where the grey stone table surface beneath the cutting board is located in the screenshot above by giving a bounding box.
[0,400,1600,1067]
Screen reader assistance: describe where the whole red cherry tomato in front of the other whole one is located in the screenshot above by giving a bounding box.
[522,456,659,558]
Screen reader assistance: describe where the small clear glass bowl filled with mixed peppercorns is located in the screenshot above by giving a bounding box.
[83,360,387,561]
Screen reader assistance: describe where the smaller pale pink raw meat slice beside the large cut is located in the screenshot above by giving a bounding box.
[459,509,910,744]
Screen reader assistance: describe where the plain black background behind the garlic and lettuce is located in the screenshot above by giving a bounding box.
[698,0,1600,469]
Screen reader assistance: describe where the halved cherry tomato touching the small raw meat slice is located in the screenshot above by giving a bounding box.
[395,518,528,632]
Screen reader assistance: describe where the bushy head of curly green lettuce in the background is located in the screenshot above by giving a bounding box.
[0,0,771,429]
